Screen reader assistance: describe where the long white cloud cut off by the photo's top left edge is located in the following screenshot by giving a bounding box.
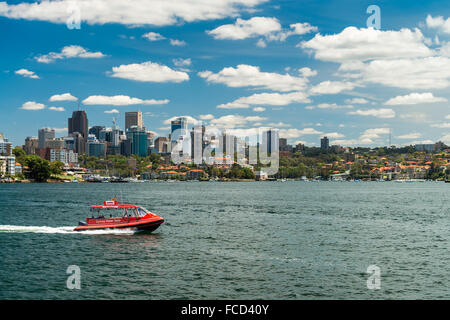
[0,0,266,26]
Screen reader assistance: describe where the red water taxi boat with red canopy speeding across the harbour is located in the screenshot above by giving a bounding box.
[74,199,164,231]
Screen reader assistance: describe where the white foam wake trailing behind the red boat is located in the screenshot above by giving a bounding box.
[0,225,136,235]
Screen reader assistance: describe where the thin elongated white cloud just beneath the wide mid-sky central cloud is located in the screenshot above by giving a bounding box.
[217,92,311,109]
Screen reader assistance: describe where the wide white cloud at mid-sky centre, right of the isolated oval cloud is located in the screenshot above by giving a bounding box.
[198,64,308,92]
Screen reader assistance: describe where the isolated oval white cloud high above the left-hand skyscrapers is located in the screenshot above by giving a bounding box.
[110,61,189,82]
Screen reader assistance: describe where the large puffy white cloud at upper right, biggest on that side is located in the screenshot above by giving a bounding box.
[298,27,433,62]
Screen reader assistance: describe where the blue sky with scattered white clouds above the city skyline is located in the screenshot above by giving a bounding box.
[0,0,450,146]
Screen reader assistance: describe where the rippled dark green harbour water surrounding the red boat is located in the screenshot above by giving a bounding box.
[0,181,450,299]
